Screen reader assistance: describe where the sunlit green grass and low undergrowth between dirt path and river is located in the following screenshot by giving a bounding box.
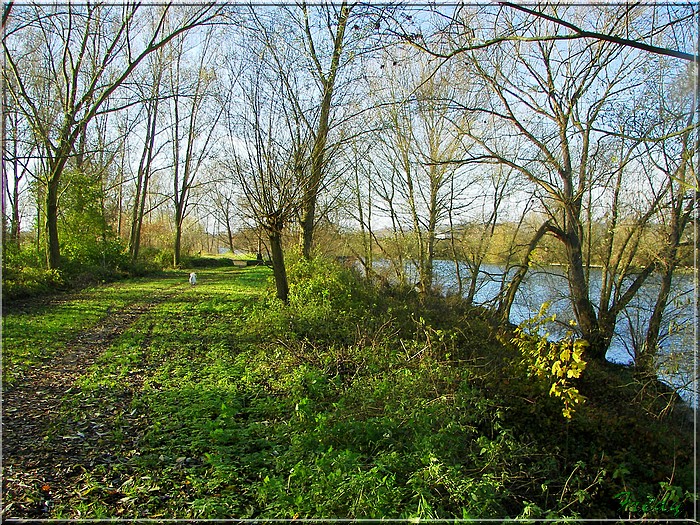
[3,260,694,520]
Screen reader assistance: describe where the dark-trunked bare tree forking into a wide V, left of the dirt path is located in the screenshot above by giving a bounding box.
[3,4,219,268]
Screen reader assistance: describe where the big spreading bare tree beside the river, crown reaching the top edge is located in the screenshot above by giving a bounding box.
[394,6,692,358]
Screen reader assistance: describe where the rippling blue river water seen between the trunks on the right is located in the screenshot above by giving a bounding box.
[434,261,697,406]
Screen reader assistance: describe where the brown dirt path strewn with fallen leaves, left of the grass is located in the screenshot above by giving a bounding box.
[2,285,184,518]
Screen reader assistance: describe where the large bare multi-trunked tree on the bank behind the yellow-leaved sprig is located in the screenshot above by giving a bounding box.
[452,6,676,358]
